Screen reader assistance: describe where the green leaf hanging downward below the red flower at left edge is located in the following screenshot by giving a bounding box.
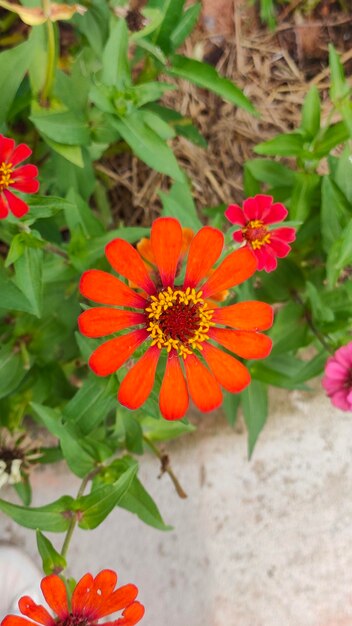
[14,246,43,317]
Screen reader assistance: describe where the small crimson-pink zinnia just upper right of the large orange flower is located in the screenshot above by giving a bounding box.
[225,194,296,272]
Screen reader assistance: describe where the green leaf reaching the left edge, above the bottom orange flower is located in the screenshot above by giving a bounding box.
[0,496,75,533]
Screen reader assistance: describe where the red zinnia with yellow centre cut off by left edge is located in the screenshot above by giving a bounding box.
[0,135,39,219]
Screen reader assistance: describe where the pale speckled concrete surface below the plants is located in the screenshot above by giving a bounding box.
[0,391,352,626]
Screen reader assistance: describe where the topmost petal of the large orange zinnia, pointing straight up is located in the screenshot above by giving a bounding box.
[151,217,182,287]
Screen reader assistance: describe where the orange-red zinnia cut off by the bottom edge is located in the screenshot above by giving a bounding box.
[1,569,144,626]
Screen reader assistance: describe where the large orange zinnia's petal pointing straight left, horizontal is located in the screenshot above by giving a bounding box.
[78,307,145,337]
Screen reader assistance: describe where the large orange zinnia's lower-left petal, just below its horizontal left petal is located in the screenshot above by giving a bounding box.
[89,329,149,376]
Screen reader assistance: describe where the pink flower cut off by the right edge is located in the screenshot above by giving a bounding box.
[322,341,352,411]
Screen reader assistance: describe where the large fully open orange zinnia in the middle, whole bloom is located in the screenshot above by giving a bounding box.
[79,218,273,420]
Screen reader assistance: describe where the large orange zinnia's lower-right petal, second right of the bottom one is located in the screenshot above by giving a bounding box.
[202,342,251,393]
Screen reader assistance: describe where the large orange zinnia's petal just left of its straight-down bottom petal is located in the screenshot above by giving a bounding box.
[117,346,160,409]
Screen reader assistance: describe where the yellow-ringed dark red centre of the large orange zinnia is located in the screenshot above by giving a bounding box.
[146,287,214,358]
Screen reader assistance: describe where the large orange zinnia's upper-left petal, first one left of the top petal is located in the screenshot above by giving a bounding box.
[105,239,155,294]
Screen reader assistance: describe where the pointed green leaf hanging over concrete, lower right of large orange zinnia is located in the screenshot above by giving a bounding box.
[241,380,268,458]
